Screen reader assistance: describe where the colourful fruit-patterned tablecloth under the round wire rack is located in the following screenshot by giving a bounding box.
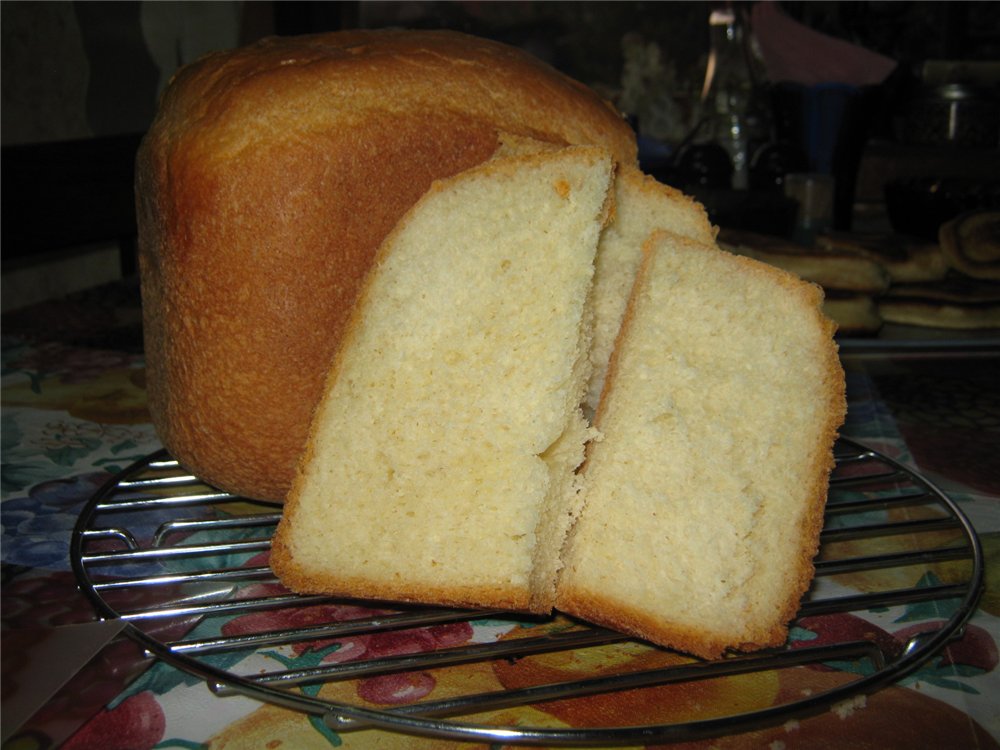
[0,283,1000,750]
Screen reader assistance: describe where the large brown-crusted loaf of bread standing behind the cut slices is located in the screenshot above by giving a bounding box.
[136,31,636,500]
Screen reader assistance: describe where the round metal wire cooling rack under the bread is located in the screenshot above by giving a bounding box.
[71,439,984,746]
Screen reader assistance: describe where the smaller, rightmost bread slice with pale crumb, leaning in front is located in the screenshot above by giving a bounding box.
[556,232,845,658]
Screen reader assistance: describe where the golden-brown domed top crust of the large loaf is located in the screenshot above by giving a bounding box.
[153,30,636,164]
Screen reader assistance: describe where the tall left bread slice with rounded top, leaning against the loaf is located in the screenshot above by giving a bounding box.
[271,146,613,612]
